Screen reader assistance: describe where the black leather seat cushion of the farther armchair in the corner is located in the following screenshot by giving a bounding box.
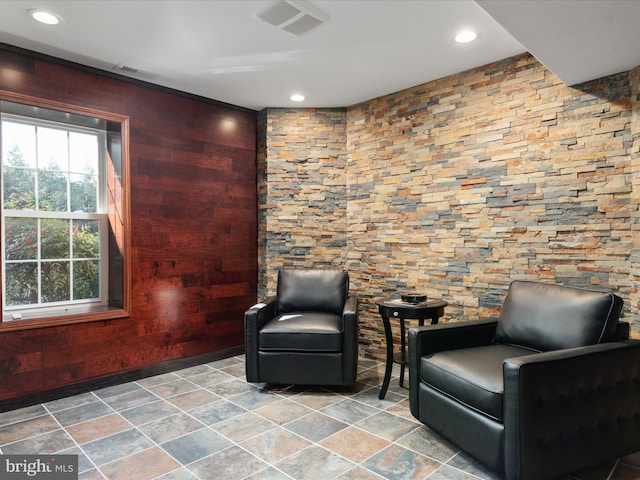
[258,312,342,352]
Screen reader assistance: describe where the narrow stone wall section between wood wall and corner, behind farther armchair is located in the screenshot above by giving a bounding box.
[258,108,347,298]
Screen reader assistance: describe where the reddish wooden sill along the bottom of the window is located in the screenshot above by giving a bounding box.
[0,306,130,333]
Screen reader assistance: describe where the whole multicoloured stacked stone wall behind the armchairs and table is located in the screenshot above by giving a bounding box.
[259,54,640,357]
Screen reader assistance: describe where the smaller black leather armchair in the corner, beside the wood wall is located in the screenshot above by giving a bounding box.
[245,269,358,386]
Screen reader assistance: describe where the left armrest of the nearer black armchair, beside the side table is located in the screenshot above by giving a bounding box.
[409,319,498,418]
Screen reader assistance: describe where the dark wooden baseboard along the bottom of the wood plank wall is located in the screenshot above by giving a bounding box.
[0,345,244,413]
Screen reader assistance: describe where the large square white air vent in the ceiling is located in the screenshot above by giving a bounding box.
[256,0,329,35]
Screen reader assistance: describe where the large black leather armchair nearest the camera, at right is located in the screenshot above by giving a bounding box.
[409,281,640,480]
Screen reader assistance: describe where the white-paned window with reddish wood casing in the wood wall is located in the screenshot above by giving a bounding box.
[0,95,129,328]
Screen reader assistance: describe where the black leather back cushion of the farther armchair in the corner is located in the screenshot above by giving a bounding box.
[276,268,349,315]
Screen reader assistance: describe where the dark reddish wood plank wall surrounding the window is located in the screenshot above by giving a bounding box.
[0,46,257,400]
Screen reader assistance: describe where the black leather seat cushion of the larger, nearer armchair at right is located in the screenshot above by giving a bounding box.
[420,345,536,422]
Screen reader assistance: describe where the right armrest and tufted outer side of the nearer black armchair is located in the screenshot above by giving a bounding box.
[503,340,640,480]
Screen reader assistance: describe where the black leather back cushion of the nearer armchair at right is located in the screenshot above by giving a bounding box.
[495,281,623,351]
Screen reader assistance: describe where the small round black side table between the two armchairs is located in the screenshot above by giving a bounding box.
[376,298,448,400]
